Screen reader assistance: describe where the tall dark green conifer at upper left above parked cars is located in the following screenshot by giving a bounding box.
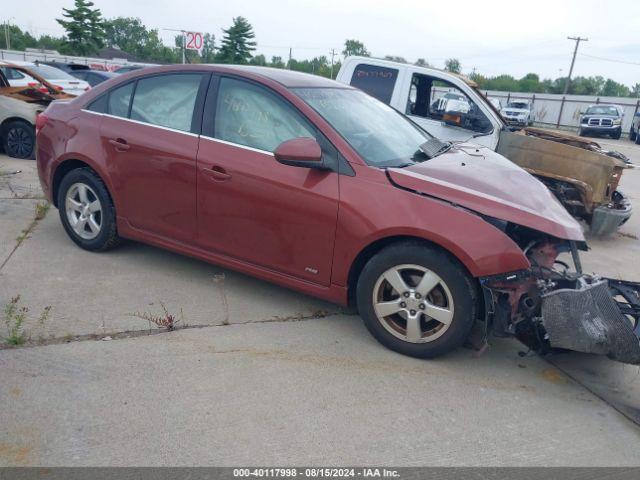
[56,0,104,55]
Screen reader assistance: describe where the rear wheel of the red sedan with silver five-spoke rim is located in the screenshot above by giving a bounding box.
[58,168,120,251]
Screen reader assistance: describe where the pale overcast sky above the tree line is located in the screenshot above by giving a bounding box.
[5,0,640,86]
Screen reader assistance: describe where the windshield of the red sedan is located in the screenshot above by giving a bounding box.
[292,88,432,167]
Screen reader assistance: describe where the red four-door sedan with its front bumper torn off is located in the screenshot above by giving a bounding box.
[37,65,640,364]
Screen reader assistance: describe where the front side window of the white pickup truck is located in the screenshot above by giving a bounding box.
[406,73,493,133]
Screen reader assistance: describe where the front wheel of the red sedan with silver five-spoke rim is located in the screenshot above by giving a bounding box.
[356,242,478,358]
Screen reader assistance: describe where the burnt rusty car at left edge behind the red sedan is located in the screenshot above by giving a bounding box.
[0,62,73,158]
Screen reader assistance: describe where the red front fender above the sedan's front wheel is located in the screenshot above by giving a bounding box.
[332,171,531,285]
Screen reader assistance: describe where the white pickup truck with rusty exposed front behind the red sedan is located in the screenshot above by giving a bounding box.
[337,57,631,235]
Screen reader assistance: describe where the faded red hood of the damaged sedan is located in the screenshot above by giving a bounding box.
[387,144,584,241]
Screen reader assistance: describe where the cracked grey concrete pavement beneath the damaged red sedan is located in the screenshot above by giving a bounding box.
[0,140,640,466]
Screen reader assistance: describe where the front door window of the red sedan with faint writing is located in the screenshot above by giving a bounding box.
[214,78,315,152]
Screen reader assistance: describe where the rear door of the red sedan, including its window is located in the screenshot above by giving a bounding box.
[100,72,210,243]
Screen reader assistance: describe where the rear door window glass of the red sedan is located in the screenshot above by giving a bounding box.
[131,73,202,132]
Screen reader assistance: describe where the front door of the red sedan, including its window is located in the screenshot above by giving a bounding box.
[197,77,338,285]
